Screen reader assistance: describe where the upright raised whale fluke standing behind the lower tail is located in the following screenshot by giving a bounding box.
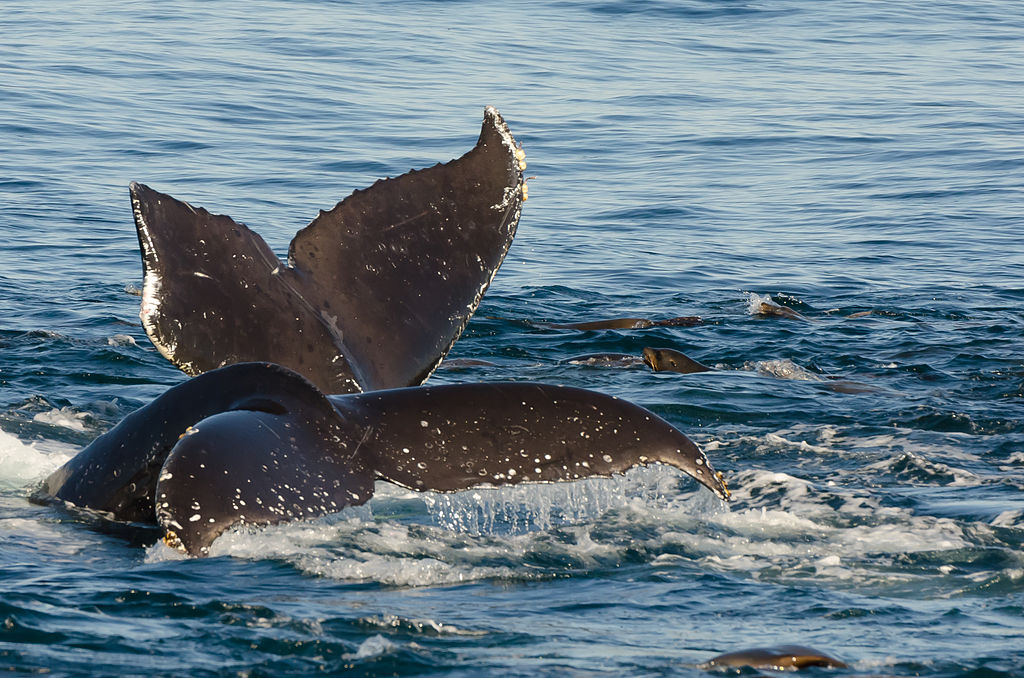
[130,107,524,393]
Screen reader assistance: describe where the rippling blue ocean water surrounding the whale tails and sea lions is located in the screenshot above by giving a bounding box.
[0,0,1024,678]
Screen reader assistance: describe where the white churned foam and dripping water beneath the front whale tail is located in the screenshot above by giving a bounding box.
[134,427,1007,590]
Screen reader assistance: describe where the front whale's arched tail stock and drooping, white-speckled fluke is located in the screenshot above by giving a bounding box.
[34,363,729,555]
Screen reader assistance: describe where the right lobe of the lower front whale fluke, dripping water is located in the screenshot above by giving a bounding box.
[330,382,729,499]
